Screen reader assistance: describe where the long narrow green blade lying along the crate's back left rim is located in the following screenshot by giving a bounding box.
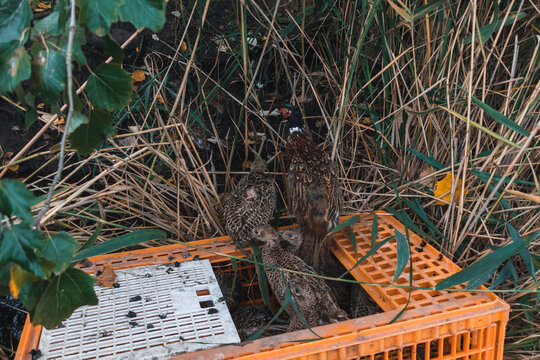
[73,229,166,261]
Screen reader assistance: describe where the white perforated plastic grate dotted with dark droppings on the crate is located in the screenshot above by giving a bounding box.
[39,260,240,359]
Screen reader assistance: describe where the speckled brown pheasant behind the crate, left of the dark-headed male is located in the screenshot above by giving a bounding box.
[222,160,276,255]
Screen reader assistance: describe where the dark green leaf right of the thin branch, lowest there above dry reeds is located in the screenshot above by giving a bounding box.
[69,110,114,155]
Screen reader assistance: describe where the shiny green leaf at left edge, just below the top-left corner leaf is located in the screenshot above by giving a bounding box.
[0,46,31,95]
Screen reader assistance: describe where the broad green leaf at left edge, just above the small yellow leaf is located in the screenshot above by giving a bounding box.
[0,223,46,279]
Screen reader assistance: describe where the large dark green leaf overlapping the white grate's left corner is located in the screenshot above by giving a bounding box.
[32,268,98,329]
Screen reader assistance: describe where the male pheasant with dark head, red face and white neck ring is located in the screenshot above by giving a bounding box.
[279,104,340,273]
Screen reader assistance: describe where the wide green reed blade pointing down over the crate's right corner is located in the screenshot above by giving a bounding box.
[435,224,528,290]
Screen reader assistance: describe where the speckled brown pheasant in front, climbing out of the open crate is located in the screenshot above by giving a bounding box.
[253,225,347,331]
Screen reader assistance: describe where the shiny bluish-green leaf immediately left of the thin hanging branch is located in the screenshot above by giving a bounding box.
[32,49,66,104]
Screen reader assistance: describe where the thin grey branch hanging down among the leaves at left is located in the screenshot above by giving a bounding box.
[34,0,77,231]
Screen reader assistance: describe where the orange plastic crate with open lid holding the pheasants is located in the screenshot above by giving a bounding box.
[16,213,509,360]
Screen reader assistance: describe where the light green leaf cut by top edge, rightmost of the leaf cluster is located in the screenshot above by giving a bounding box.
[120,0,166,31]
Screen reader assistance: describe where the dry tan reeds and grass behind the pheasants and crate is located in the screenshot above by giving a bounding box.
[5,0,540,358]
